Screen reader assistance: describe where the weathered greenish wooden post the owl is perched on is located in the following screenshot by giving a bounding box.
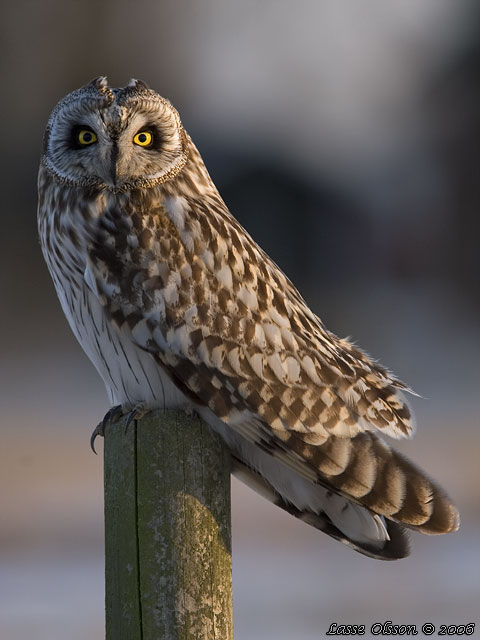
[104,410,233,640]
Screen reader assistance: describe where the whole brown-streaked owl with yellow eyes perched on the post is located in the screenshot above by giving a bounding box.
[38,77,459,560]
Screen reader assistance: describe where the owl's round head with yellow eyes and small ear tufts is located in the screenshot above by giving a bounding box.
[43,77,187,191]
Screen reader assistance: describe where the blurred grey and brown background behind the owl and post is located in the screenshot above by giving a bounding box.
[0,0,480,640]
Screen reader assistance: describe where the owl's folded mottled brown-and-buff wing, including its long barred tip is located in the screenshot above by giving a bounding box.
[85,198,458,533]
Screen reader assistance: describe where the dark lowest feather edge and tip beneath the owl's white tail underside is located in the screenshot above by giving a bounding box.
[232,458,410,560]
